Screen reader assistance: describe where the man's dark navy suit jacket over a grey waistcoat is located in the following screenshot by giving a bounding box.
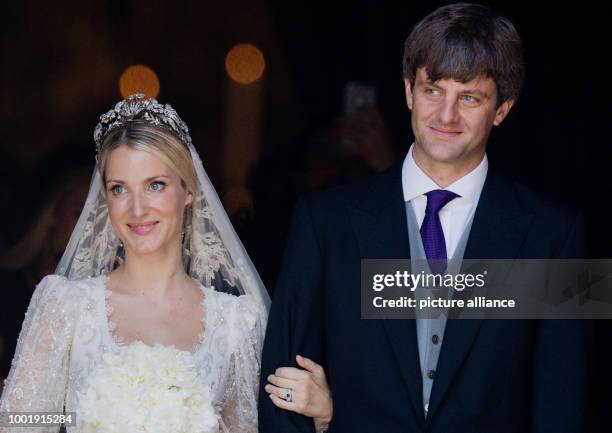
[259,165,588,433]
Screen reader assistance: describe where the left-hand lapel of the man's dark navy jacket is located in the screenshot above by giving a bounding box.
[349,164,425,425]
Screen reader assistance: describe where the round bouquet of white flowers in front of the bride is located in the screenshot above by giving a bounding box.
[76,342,219,433]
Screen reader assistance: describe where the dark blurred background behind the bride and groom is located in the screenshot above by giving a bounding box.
[0,0,612,428]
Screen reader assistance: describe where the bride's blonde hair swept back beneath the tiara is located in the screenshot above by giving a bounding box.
[98,122,198,198]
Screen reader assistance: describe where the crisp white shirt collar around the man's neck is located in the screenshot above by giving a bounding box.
[402,145,489,205]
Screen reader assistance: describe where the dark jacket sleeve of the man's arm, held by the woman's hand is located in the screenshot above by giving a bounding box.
[259,199,323,433]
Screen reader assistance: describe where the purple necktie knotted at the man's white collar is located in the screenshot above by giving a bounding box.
[421,189,459,274]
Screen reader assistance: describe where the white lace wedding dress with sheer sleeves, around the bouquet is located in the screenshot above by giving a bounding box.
[0,275,264,433]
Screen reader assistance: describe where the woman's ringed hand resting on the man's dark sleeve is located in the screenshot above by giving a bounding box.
[265,355,334,429]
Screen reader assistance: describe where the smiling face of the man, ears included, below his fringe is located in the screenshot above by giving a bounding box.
[406,67,512,167]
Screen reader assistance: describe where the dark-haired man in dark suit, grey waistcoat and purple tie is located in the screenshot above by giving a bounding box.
[259,4,587,433]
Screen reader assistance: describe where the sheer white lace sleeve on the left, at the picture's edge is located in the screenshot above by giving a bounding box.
[0,275,76,433]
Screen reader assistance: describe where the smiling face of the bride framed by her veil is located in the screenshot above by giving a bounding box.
[105,146,192,257]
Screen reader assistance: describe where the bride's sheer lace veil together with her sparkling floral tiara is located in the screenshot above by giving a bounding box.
[56,94,270,322]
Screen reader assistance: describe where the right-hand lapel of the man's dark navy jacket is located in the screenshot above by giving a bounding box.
[427,172,532,420]
